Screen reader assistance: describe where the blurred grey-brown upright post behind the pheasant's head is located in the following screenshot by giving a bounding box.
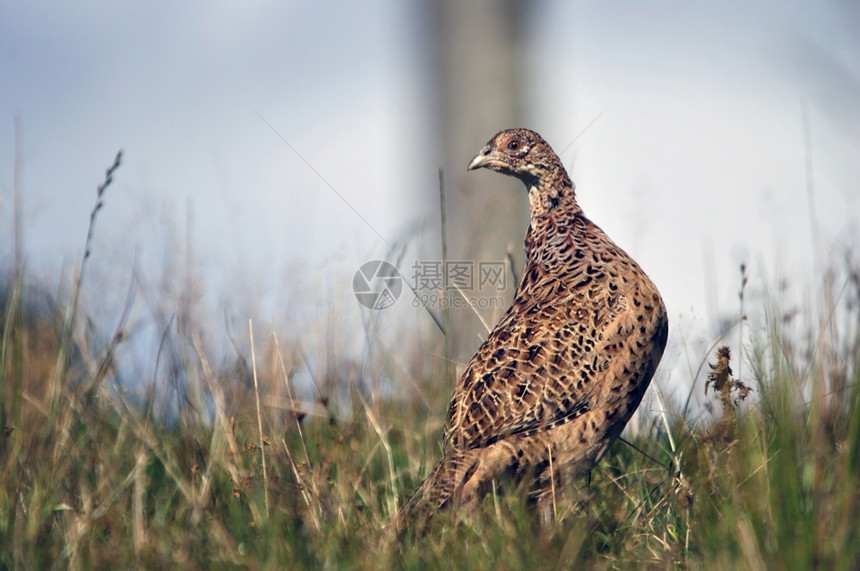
[425,0,528,361]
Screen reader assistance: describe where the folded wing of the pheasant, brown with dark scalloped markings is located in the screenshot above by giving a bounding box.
[446,272,636,449]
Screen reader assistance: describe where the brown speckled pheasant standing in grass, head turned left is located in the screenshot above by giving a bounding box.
[398,129,668,522]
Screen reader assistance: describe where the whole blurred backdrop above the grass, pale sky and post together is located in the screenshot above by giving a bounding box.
[0,0,860,413]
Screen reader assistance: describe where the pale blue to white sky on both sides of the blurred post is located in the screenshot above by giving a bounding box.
[0,1,860,404]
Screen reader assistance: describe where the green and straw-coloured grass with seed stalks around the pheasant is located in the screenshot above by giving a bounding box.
[0,155,860,569]
